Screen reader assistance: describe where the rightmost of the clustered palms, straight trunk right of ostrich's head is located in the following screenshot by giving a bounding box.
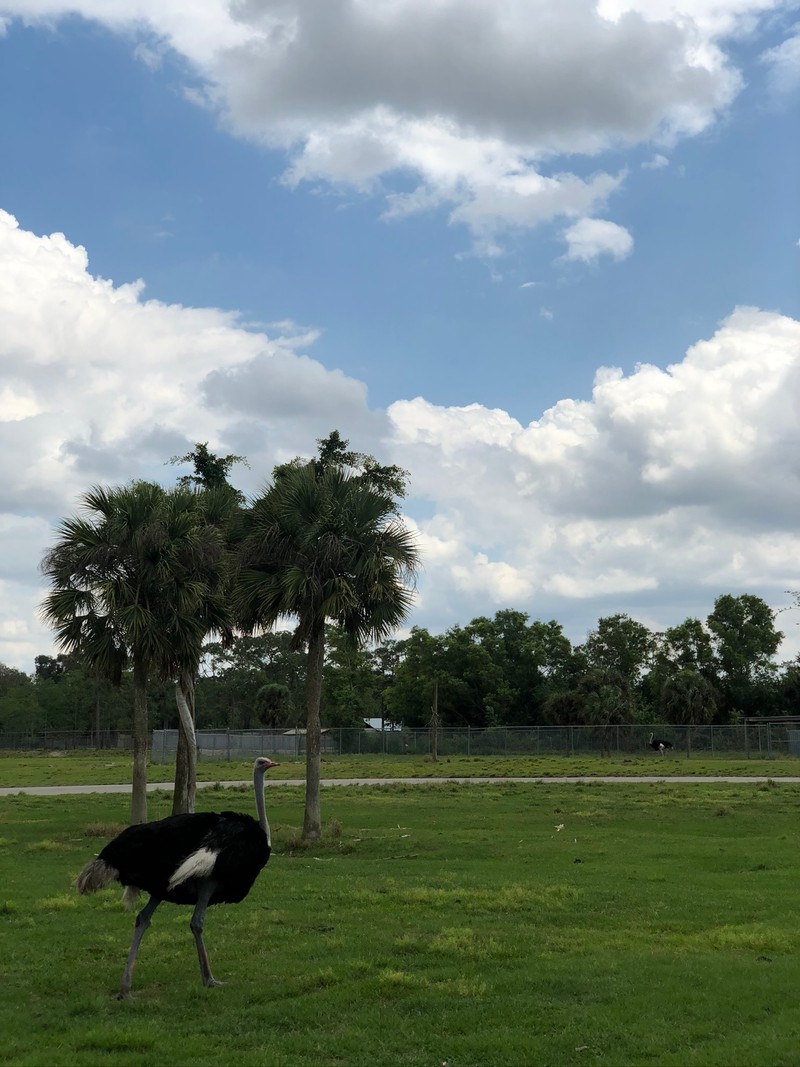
[237,454,418,840]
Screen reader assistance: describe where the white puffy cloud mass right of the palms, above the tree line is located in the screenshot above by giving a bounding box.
[389,307,800,640]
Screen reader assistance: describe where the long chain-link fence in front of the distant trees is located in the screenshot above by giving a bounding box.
[0,720,800,763]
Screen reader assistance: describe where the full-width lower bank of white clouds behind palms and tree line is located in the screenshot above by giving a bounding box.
[0,213,800,670]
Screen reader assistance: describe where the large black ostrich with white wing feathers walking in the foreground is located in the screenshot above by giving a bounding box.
[76,755,277,1000]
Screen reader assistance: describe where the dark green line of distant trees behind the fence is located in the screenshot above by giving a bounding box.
[6,594,800,736]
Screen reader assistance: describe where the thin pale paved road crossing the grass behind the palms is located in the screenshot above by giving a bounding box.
[0,775,800,797]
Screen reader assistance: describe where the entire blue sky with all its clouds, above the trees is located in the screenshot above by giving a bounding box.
[0,0,800,670]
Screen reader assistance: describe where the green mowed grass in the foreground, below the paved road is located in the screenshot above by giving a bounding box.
[0,782,800,1067]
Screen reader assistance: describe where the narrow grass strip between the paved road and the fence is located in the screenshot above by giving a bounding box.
[0,750,800,786]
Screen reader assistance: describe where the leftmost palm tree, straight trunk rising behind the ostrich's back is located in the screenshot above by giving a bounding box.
[42,481,231,823]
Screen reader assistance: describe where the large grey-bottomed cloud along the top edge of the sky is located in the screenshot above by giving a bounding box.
[3,0,789,255]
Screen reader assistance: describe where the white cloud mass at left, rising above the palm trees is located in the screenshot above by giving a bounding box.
[0,211,385,663]
